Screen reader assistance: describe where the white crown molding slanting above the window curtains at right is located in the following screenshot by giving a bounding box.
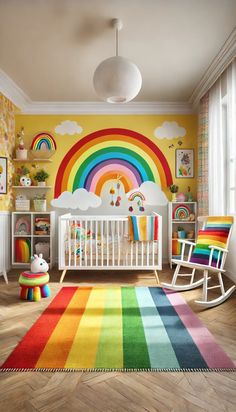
[189,27,236,107]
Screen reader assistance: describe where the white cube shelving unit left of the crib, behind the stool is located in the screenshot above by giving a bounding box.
[11,211,55,268]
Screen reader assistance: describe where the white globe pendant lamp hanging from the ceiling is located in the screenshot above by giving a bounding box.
[93,19,142,103]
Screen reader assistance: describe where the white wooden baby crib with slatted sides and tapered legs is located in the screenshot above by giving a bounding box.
[58,213,162,283]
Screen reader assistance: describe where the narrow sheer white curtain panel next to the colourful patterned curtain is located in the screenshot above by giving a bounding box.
[208,79,226,215]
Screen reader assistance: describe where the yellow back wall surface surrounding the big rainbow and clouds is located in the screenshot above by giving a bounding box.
[16,114,197,204]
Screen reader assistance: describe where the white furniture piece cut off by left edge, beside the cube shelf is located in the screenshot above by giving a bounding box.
[0,211,11,283]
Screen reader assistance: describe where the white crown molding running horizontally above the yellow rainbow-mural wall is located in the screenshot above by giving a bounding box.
[22,101,193,115]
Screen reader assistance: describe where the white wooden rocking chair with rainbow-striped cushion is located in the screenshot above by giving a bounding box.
[162,216,236,307]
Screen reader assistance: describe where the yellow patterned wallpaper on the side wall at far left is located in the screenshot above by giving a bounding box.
[0,93,15,210]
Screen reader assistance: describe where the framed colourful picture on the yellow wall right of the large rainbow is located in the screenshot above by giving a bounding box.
[175,149,194,178]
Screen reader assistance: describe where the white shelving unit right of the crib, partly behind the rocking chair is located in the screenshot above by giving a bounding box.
[168,202,197,268]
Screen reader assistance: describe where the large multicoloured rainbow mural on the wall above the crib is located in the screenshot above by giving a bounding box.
[54,128,173,198]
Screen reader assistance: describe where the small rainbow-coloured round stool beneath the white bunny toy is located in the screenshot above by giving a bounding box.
[19,272,51,302]
